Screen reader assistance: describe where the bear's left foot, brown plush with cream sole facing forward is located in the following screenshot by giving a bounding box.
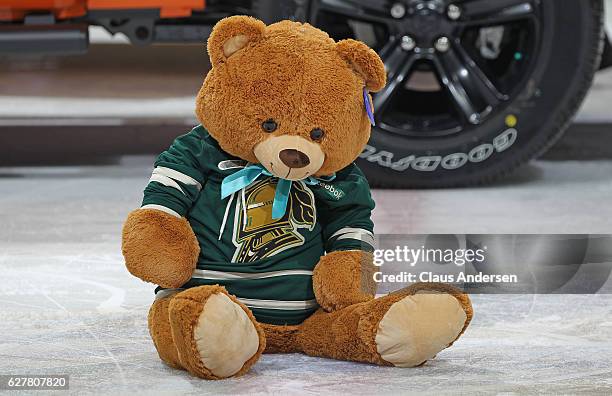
[169,285,266,379]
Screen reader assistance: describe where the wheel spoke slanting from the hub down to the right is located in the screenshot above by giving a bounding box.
[433,43,505,124]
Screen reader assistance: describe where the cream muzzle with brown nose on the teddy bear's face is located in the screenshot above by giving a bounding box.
[253,135,325,181]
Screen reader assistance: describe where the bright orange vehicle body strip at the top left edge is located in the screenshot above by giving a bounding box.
[0,0,206,21]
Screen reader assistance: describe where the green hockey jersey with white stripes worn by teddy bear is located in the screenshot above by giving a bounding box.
[142,126,374,324]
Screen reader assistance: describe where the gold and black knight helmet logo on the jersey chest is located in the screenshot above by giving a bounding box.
[232,178,317,263]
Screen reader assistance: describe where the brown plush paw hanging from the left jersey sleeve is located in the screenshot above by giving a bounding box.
[122,209,200,288]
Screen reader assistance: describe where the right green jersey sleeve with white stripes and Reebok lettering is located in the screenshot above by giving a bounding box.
[319,165,375,253]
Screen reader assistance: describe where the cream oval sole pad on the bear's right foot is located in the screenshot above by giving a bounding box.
[375,291,467,367]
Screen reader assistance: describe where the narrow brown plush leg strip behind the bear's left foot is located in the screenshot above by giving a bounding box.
[148,293,183,369]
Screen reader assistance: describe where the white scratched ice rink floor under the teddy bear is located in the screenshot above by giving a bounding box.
[0,158,612,395]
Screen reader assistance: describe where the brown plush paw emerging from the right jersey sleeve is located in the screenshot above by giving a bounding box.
[313,250,376,312]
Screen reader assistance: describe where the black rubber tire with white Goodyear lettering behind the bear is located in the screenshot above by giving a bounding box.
[358,0,603,188]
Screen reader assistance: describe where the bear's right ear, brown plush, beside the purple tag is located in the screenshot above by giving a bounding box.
[336,39,387,92]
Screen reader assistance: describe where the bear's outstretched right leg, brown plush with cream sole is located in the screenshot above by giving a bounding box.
[298,284,472,367]
